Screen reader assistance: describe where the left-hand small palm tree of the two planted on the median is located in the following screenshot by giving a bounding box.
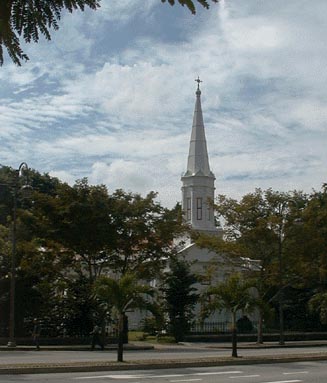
[94,273,154,362]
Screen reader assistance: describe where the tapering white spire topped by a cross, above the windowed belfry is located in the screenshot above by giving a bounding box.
[185,77,214,177]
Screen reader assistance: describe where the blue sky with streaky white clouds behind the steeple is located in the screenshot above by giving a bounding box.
[0,0,327,207]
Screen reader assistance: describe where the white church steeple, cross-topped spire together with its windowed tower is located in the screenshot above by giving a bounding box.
[182,78,217,232]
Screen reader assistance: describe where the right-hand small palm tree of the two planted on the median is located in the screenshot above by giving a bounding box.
[202,273,255,358]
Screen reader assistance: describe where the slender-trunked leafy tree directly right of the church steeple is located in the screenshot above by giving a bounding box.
[216,189,284,343]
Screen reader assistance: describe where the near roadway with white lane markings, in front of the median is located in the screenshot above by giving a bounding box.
[0,362,327,383]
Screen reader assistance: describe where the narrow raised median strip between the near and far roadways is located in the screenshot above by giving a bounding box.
[0,353,327,375]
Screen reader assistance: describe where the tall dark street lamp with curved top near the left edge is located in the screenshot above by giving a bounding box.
[7,162,31,348]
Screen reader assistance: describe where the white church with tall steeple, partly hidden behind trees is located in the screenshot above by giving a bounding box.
[128,78,257,329]
